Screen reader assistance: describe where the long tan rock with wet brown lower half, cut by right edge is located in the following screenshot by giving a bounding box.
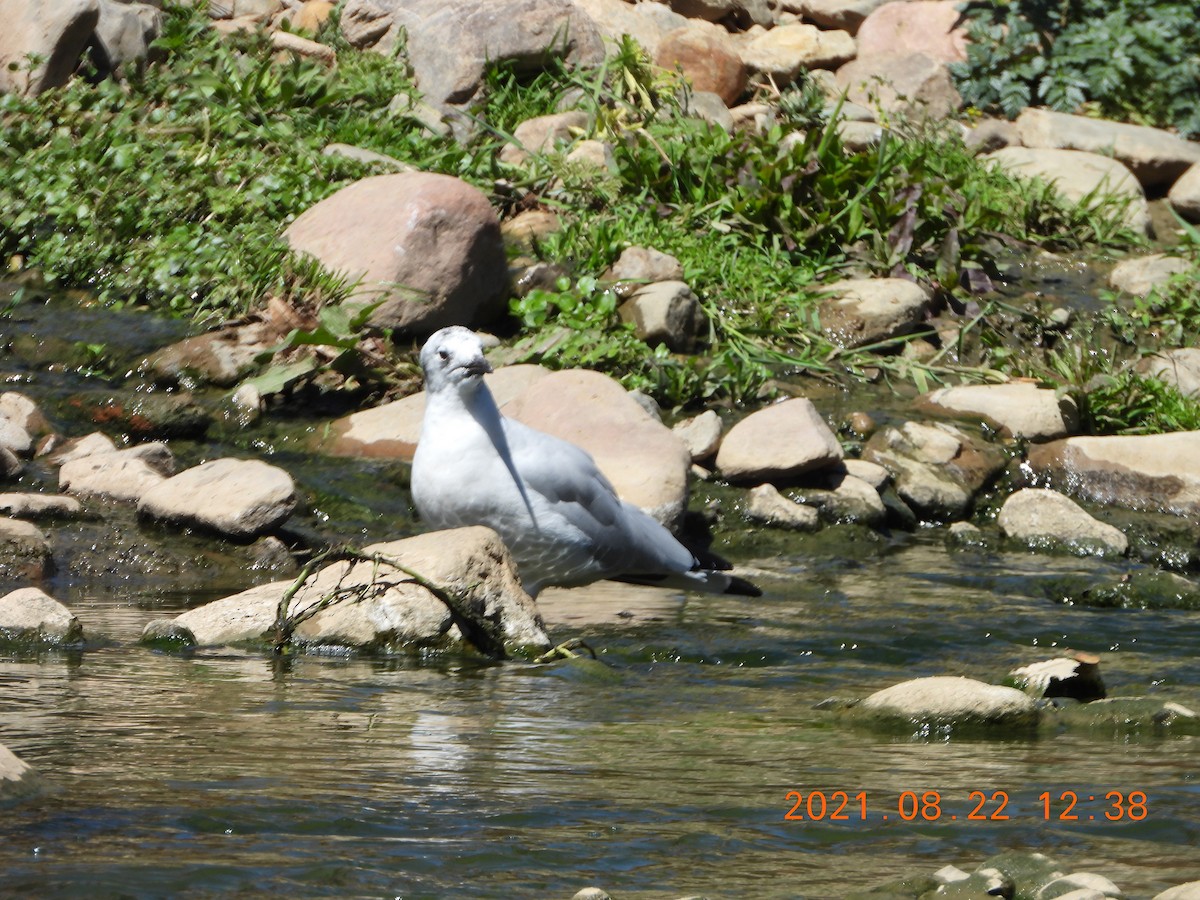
[1027,431,1200,518]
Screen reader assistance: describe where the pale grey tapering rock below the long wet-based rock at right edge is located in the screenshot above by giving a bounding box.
[996,487,1129,556]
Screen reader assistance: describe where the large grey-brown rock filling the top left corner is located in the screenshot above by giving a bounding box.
[0,0,100,96]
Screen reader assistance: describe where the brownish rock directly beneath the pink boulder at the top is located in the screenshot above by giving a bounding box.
[838,53,962,121]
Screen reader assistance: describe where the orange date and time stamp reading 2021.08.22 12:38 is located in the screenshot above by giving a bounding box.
[784,791,1150,822]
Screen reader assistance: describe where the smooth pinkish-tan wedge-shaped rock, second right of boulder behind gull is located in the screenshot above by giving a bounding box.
[716,397,842,484]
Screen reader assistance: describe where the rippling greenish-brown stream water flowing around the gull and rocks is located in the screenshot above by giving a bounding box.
[0,292,1200,900]
